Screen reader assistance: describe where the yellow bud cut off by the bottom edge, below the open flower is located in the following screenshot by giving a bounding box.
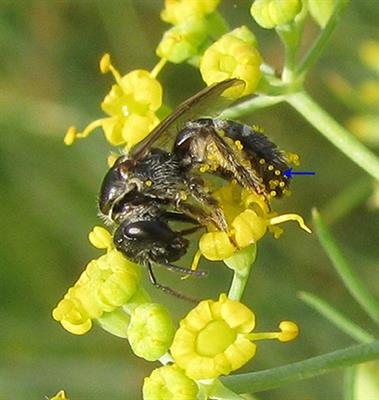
[143,365,198,400]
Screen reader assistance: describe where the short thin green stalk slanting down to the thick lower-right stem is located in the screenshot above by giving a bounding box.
[299,292,375,343]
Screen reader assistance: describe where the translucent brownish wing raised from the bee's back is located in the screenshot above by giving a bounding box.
[131,78,245,159]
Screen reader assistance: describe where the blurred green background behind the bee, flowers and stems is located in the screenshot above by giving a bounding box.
[0,0,379,400]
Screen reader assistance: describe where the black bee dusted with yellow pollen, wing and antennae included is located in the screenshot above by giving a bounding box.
[99,79,289,298]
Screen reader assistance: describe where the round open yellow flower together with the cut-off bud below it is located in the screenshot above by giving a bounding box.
[143,294,299,400]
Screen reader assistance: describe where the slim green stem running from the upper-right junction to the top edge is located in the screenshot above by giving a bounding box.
[295,0,350,77]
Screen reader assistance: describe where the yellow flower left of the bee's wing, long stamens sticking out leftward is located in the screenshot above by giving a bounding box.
[64,54,164,149]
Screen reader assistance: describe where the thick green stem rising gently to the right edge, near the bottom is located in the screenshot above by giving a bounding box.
[221,340,379,393]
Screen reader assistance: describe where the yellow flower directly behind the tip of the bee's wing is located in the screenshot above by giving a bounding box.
[200,26,262,96]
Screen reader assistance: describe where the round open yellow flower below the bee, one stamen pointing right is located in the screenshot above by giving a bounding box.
[171,294,298,380]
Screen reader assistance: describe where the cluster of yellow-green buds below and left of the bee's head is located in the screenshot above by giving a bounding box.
[53,227,174,361]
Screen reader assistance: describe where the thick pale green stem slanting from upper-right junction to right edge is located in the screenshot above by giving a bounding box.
[286,91,379,180]
